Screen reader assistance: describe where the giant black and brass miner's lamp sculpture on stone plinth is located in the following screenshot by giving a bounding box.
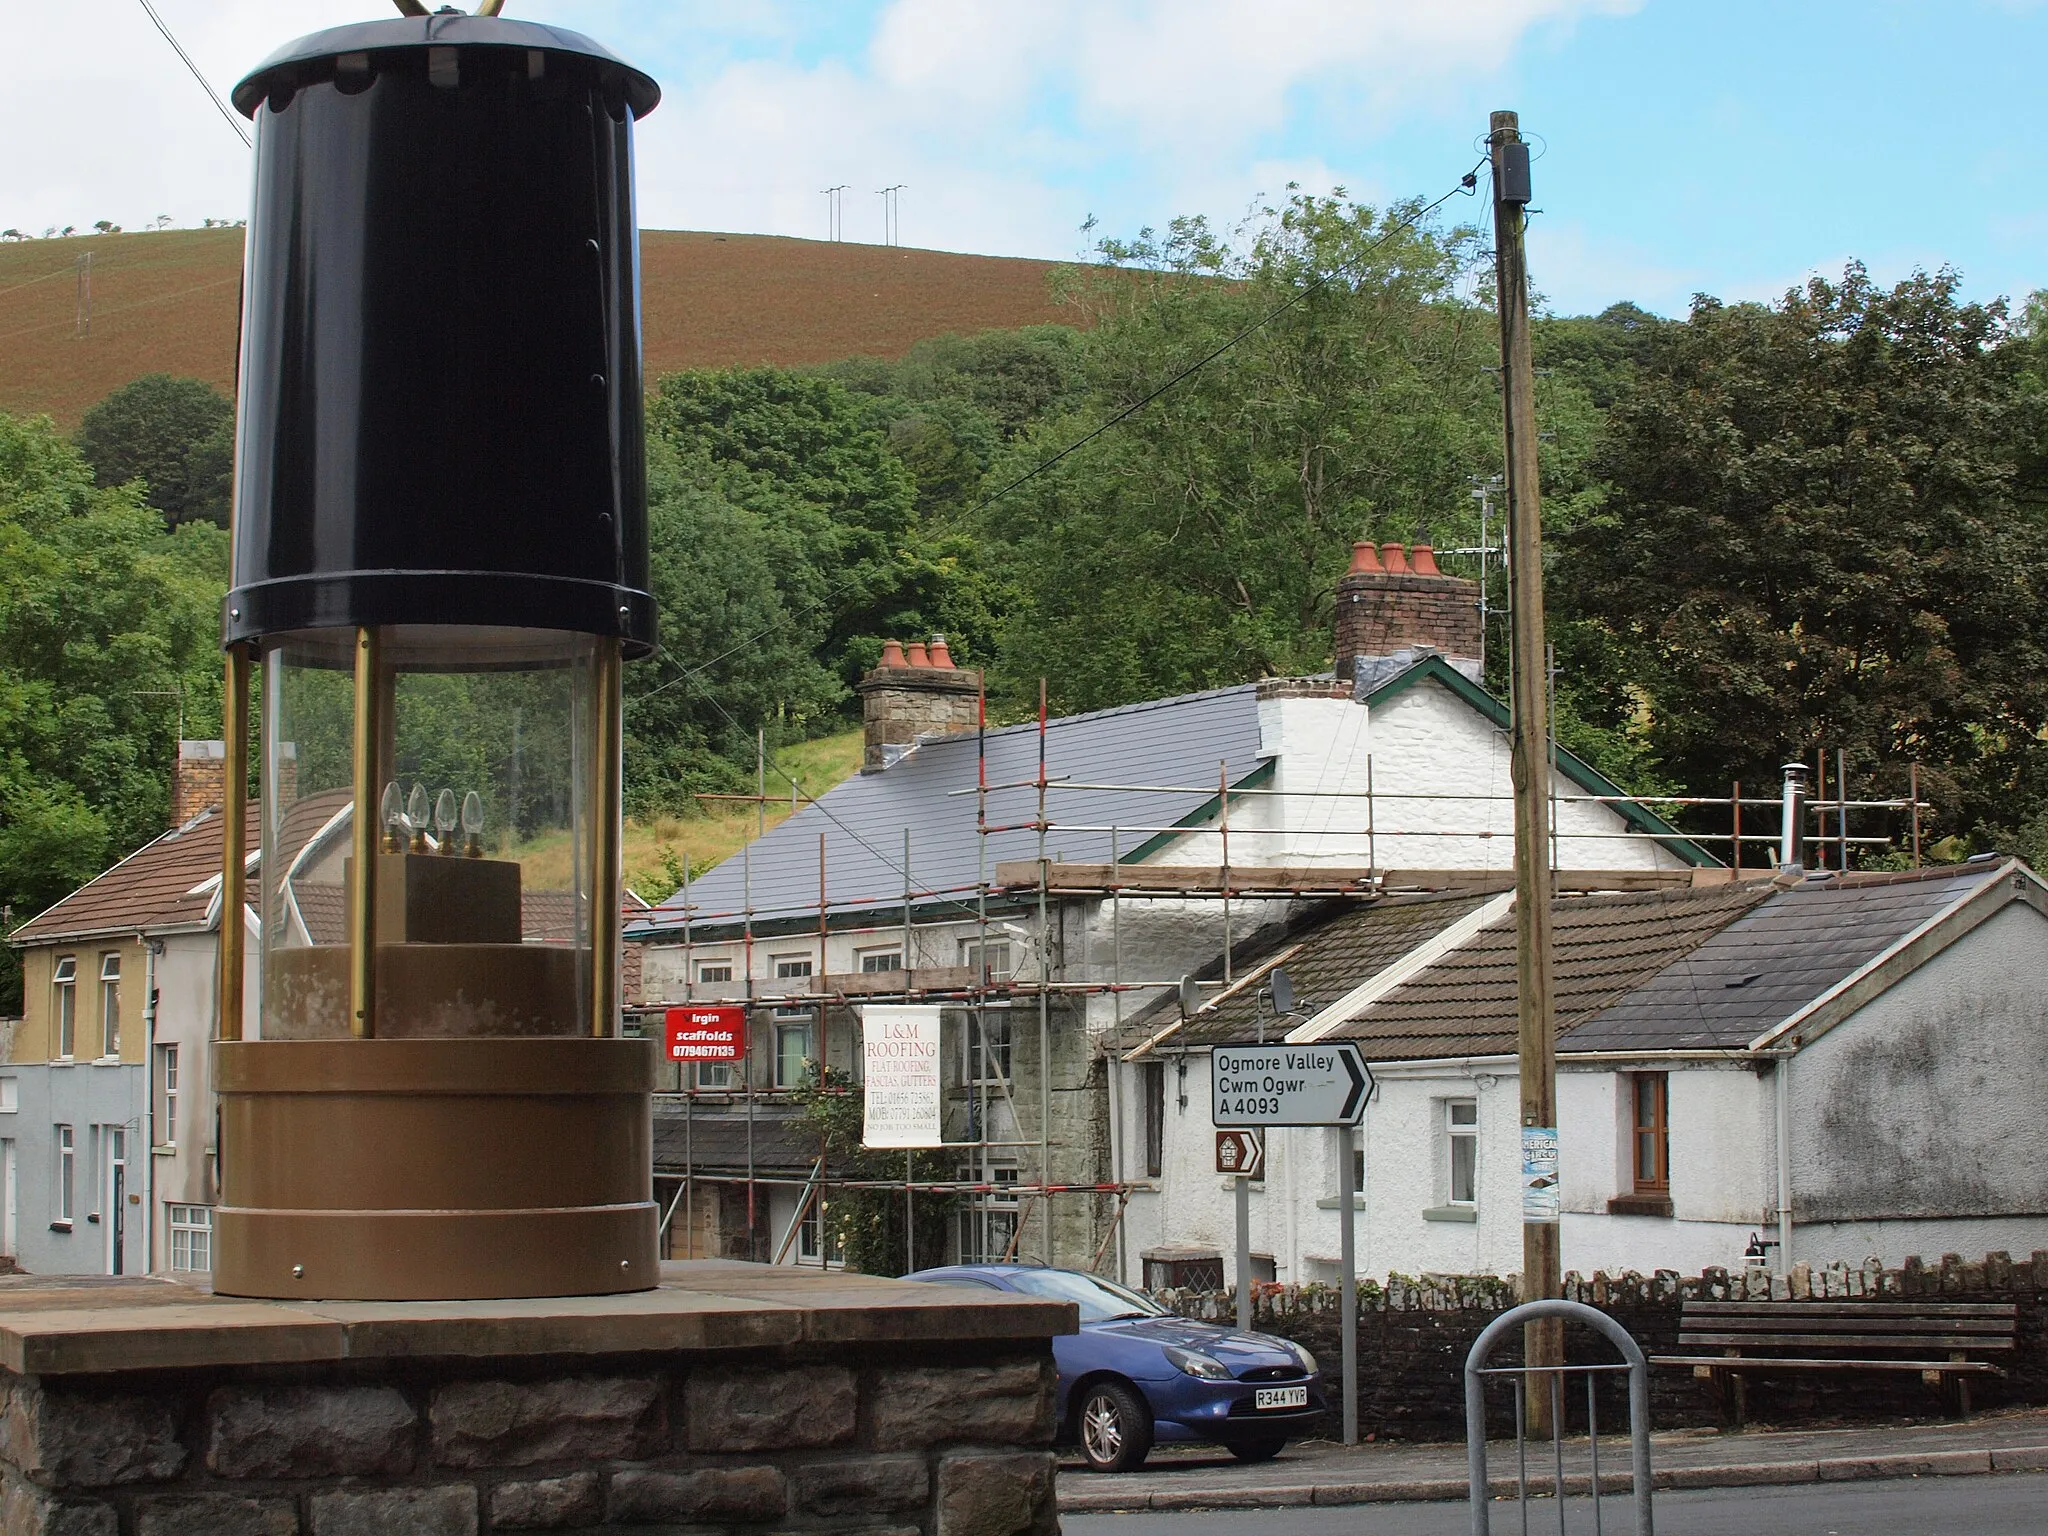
[213,4,659,1298]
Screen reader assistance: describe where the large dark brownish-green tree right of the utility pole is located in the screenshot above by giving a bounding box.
[1550,266,2048,856]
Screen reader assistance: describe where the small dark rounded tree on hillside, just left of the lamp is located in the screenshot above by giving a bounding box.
[78,373,236,528]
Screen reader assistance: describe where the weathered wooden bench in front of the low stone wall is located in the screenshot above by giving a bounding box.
[1651,1298,2019,1423]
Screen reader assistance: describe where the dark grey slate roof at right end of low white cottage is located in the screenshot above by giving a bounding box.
[1563,860,1999,1051]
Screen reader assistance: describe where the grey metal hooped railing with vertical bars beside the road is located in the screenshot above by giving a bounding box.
[1464,1300,1655,1536]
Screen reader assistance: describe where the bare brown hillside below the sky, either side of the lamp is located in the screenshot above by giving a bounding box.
[0,229,1073,430]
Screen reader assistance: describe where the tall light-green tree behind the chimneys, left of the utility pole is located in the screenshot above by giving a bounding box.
[975,193,1499,709]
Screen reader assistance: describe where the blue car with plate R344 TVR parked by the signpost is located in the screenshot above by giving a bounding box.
[909,1264,1323,1473]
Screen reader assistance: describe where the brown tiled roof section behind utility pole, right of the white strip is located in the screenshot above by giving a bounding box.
[1325,881,1774,1061]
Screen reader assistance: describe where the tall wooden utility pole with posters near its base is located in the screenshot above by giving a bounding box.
[1487,113,1565,1434]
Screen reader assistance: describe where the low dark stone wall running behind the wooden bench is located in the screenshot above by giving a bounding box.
[1157,1251,2048,1440]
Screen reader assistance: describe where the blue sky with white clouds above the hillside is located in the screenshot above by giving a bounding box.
[16,0,2048,313]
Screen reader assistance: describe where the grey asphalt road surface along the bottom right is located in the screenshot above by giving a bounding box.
[1061,1473,2048,1536]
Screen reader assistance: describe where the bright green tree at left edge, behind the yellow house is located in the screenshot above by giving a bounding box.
[0,416,227,1012]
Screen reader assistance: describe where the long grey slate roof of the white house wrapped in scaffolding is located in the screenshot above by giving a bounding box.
[627,684,1268,940]
